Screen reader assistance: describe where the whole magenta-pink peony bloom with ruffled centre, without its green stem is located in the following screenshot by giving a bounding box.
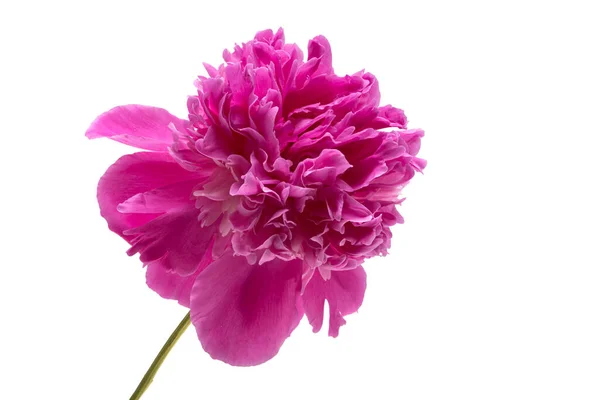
[86,29,425,365]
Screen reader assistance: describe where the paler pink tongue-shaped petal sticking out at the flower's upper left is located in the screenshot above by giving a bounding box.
[85,104,186,151]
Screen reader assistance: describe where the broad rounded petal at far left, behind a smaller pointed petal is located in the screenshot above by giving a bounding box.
[98,153,196,240]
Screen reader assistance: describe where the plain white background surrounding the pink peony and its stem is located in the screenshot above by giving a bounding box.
[0,0,600,400]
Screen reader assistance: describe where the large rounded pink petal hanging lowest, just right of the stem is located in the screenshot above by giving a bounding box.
[191,253,302,366]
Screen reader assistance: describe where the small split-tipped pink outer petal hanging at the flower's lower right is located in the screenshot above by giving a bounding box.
[302,267,367,337]
